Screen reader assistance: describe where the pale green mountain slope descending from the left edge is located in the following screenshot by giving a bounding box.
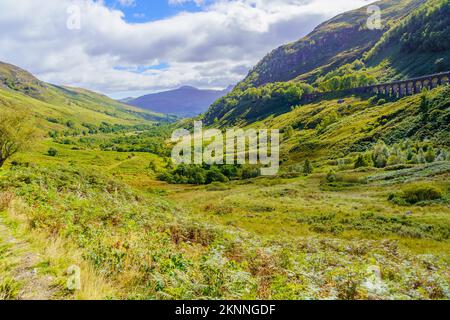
[0,62,172,130]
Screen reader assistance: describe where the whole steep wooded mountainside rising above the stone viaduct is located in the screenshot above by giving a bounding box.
[204,0,450,126]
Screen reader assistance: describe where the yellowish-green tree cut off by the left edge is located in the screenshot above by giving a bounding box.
[0,111,36,168]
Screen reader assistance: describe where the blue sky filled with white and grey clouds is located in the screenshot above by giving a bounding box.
[0,0,368,98]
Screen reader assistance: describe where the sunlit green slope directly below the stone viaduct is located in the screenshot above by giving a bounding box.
[262,86,450,163]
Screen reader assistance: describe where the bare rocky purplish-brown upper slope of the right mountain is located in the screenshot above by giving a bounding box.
[238,0,425,89]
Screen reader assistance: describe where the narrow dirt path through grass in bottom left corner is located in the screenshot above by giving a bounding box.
[0,217,56,300]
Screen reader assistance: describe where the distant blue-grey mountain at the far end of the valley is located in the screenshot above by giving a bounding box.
[124,86,232,117]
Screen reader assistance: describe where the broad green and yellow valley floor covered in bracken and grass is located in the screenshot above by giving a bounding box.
[0,141,450,299]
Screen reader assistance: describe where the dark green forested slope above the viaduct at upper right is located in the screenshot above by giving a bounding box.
[365,0,450,80]
